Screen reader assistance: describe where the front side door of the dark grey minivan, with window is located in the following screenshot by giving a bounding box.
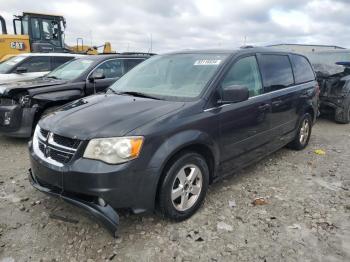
[219,55,271,173]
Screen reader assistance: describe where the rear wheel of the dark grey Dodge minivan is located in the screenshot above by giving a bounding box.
[288,113,312,150]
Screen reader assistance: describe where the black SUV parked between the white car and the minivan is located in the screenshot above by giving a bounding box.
[0,53,150,137]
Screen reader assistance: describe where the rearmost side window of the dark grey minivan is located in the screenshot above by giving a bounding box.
[291,55,315,84]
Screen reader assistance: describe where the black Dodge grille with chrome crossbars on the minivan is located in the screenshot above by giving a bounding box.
[37,128,81,164]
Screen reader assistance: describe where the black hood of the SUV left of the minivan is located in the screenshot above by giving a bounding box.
[0,77,67,95]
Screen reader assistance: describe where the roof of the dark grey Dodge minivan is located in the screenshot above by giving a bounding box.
[165,47,300,55]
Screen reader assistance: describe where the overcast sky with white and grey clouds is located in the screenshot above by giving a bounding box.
[0,0,350,53]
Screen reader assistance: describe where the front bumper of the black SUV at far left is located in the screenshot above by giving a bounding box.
[0,104,37,137]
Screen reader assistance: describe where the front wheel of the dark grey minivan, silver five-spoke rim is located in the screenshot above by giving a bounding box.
[158,152,209,221]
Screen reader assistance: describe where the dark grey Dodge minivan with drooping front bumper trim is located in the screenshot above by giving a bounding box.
[29,48,318,236]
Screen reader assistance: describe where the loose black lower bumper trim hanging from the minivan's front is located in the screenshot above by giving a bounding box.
[29,169,119,237]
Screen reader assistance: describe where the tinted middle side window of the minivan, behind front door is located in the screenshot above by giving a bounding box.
[259,54,294,92]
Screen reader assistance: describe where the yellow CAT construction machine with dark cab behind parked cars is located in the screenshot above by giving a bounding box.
[0,12,115,62]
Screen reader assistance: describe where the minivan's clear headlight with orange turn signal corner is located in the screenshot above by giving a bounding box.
[84,136,143,164]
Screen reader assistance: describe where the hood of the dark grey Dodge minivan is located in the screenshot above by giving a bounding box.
[39,94,184,140]
